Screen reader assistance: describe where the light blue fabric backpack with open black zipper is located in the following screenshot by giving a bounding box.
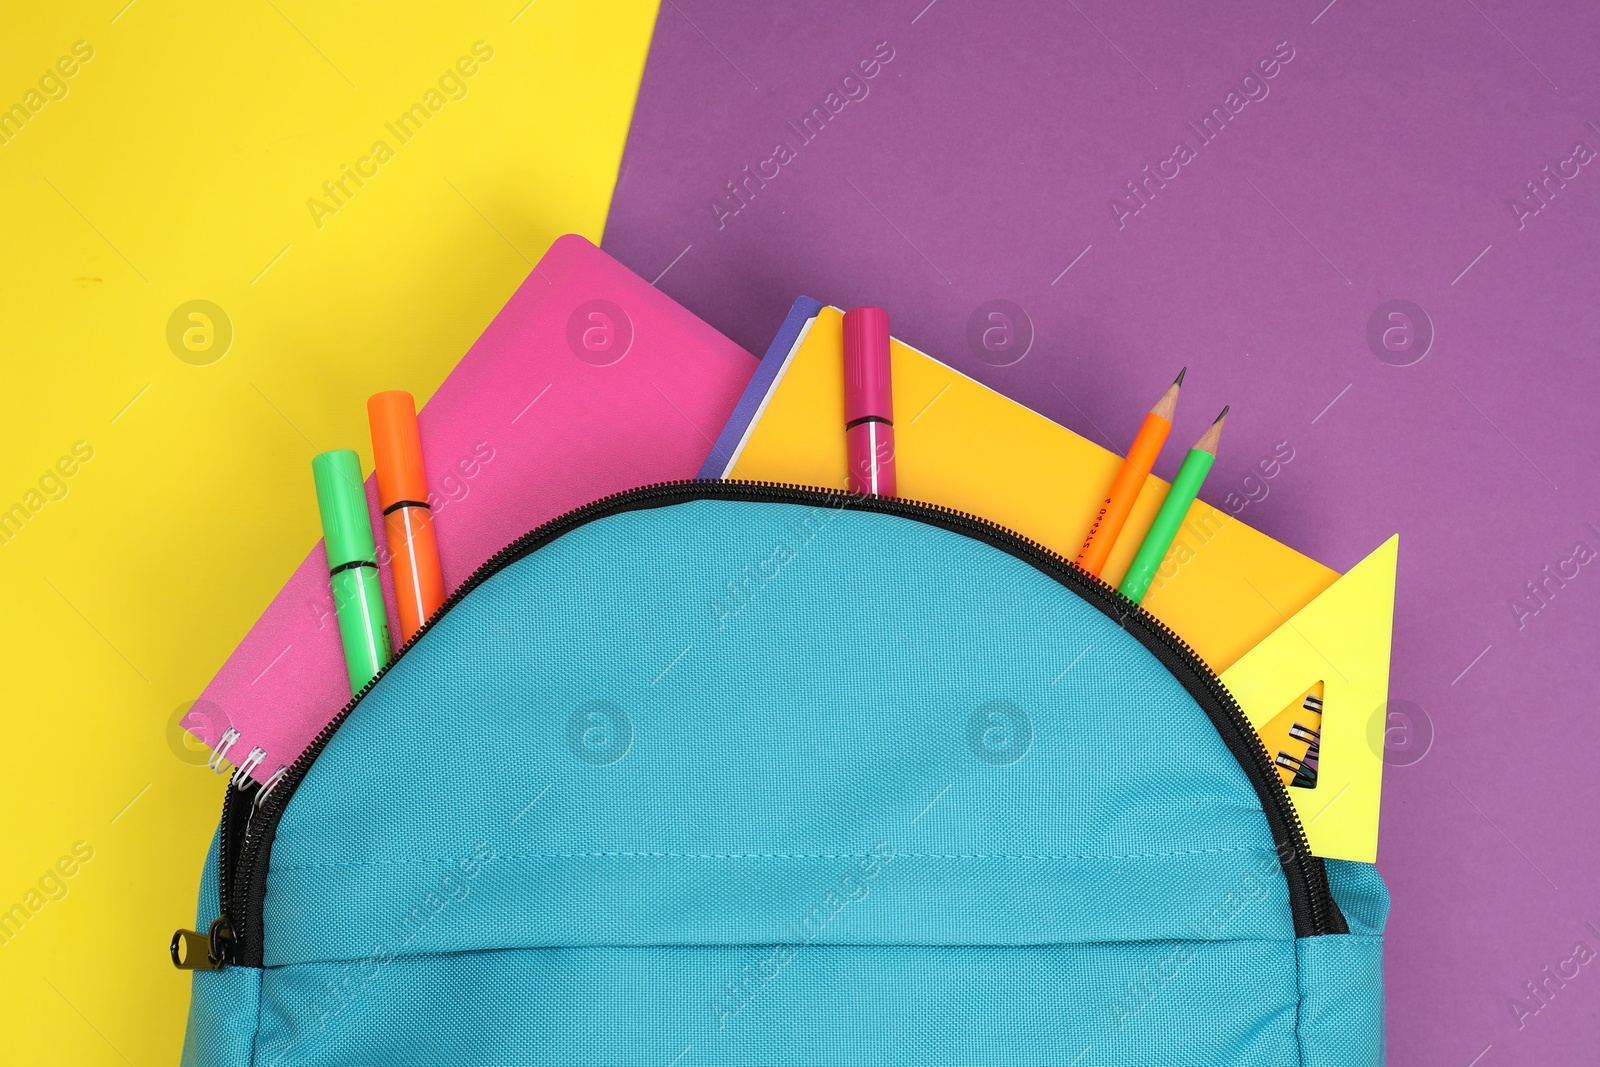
[174,482,1387,1067]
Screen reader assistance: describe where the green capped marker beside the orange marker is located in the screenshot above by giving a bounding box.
[310,448,389,694]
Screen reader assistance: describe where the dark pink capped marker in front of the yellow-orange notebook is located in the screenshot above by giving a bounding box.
[845,307,894,496]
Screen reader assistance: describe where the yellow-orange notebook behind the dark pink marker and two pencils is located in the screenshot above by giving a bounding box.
[712,298,1339,672]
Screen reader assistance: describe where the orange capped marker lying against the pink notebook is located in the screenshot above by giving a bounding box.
[366,389,445,641]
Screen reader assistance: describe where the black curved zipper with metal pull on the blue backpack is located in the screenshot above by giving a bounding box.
[173,480,1349,969]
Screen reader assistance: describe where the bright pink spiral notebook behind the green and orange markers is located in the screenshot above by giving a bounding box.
[182,235,757,782]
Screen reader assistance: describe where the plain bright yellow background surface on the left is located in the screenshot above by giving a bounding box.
[0,0,656,1067]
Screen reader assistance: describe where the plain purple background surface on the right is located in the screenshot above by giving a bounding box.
[605,0,1600,1067]
